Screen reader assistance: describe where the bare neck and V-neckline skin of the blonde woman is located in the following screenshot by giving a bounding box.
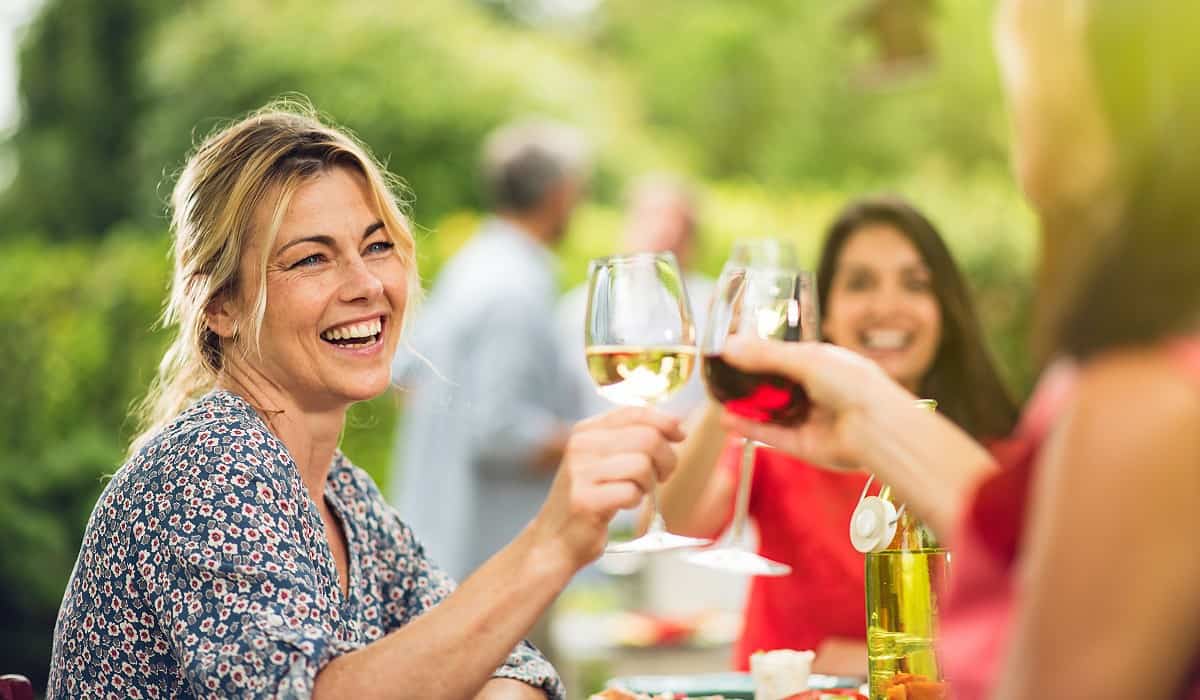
[217,361,348,504]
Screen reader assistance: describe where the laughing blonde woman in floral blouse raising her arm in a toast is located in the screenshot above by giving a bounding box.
[48,107,682,698]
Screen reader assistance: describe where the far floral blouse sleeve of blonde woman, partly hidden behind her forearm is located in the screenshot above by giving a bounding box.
[354,468,566,700]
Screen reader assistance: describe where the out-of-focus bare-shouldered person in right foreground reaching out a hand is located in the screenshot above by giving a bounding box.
[726,0,1200,700]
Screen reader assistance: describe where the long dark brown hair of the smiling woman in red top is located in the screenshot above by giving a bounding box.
[817,197,1016,439]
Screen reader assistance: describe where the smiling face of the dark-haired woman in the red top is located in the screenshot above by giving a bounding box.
[822,223,942,391]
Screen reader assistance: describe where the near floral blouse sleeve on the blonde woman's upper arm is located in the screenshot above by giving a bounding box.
[152,457,353,698]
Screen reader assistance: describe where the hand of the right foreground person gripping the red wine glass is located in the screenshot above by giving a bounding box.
[722,337,913,469]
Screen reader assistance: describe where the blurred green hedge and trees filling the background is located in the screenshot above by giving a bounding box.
[0,0,1033,691]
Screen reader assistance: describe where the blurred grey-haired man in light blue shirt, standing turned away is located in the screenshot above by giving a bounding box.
[391,122,588,580]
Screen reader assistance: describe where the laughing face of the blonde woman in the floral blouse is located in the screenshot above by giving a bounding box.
[218,167,407,411]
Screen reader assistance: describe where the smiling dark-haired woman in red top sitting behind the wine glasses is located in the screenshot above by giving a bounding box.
[659,197,1016,676]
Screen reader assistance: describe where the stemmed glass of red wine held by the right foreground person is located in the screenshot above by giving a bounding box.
[688,264,820,576]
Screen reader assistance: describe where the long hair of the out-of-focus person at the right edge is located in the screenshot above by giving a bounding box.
[1056,0,1200,358]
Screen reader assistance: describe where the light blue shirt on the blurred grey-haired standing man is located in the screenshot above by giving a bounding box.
[390,219,577,580]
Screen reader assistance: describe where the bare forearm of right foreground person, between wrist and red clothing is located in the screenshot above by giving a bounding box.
[845,390,996,538]
